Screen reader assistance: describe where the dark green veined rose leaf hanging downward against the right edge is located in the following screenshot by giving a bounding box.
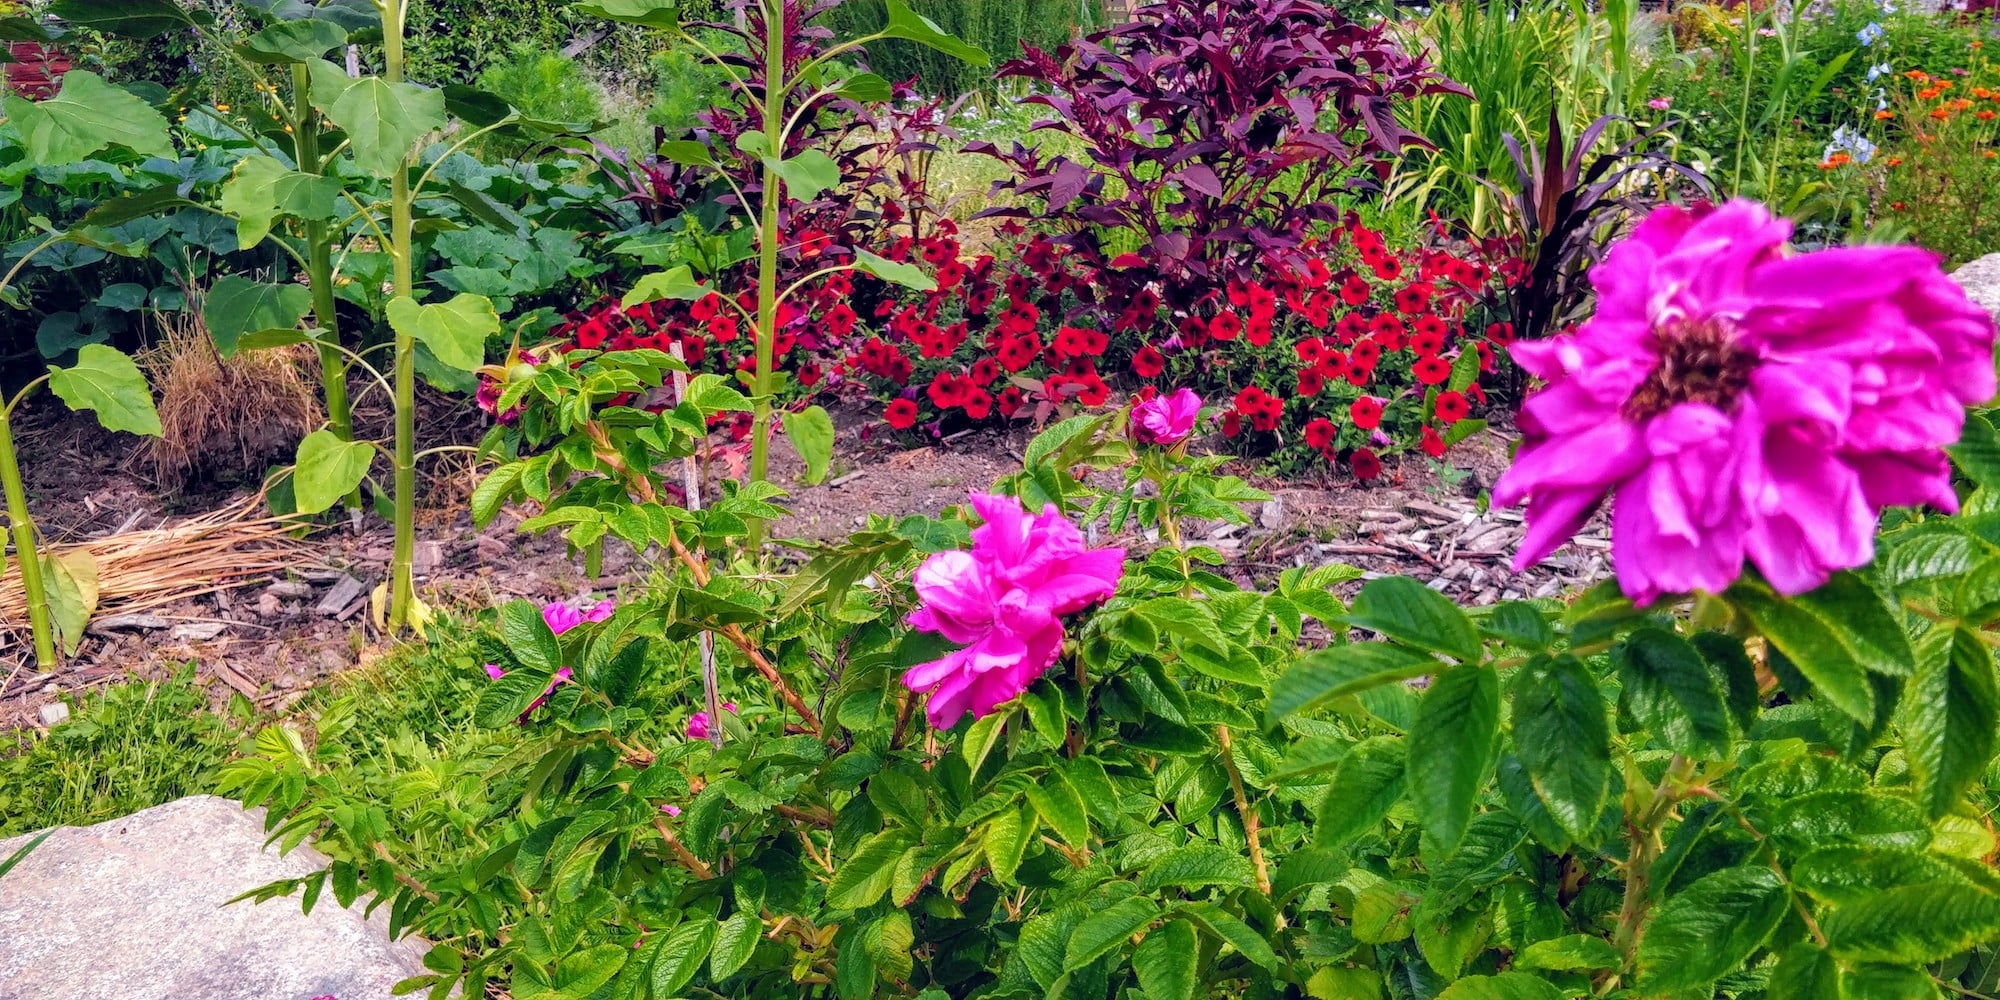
[1900,628,2000,818]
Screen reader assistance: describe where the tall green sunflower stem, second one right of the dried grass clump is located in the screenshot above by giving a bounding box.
[380,0,416,632]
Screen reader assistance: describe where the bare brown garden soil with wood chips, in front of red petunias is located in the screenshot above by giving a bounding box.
[0,398,1610,730]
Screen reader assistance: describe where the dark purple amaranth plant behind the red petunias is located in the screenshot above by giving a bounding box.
[970,0,1464,312]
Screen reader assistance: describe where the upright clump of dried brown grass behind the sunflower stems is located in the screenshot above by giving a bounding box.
[140,310,322,490]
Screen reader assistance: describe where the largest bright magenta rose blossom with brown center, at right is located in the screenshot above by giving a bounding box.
[1494,200,1994,604]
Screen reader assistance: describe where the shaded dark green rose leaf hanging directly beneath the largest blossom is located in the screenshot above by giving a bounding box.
[1612,628,1734,760]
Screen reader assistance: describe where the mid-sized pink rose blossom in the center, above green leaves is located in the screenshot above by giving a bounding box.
[902,494,1124,730]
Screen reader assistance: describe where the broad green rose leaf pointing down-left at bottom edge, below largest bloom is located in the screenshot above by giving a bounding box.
[1638,862,1792,994]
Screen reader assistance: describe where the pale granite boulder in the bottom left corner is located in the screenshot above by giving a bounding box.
[0,796,426,1000]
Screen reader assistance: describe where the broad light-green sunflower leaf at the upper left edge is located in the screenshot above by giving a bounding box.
[0,70,174,166]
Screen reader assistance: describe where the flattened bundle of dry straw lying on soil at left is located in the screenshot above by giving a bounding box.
[0,494,312,628]
